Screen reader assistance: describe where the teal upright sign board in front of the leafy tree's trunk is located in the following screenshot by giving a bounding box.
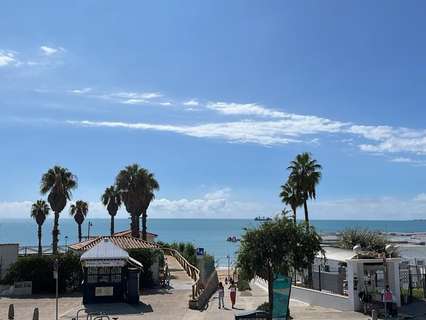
[272,274,291,319]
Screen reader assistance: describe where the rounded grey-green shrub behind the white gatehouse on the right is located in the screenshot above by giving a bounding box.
[339,228,388,253]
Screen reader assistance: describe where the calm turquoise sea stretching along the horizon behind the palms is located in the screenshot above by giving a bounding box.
[0,218,426,266]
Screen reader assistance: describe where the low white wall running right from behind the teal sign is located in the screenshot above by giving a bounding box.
[291,286,354,311]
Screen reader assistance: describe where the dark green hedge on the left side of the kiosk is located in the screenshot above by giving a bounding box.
[3,253,83,293]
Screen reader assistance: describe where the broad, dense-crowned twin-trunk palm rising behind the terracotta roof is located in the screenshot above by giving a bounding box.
[116,164,159,240]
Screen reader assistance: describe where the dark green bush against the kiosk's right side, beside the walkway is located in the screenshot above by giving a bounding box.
[128,249,164,288]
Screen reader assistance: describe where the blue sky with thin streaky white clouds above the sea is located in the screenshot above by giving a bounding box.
[0,1,426,219]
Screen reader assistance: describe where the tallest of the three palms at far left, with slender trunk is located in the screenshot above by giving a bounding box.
[40,166,77,254]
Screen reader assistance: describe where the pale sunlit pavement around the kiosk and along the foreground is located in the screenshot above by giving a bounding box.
[0,257,369,320]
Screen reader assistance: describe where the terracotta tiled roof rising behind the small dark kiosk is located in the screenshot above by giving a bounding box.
[69,236,160,252]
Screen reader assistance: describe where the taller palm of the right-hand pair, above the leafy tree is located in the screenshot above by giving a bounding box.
[287,152,322,227]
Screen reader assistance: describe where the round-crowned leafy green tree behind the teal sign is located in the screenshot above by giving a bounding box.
[237,217,321,310]
